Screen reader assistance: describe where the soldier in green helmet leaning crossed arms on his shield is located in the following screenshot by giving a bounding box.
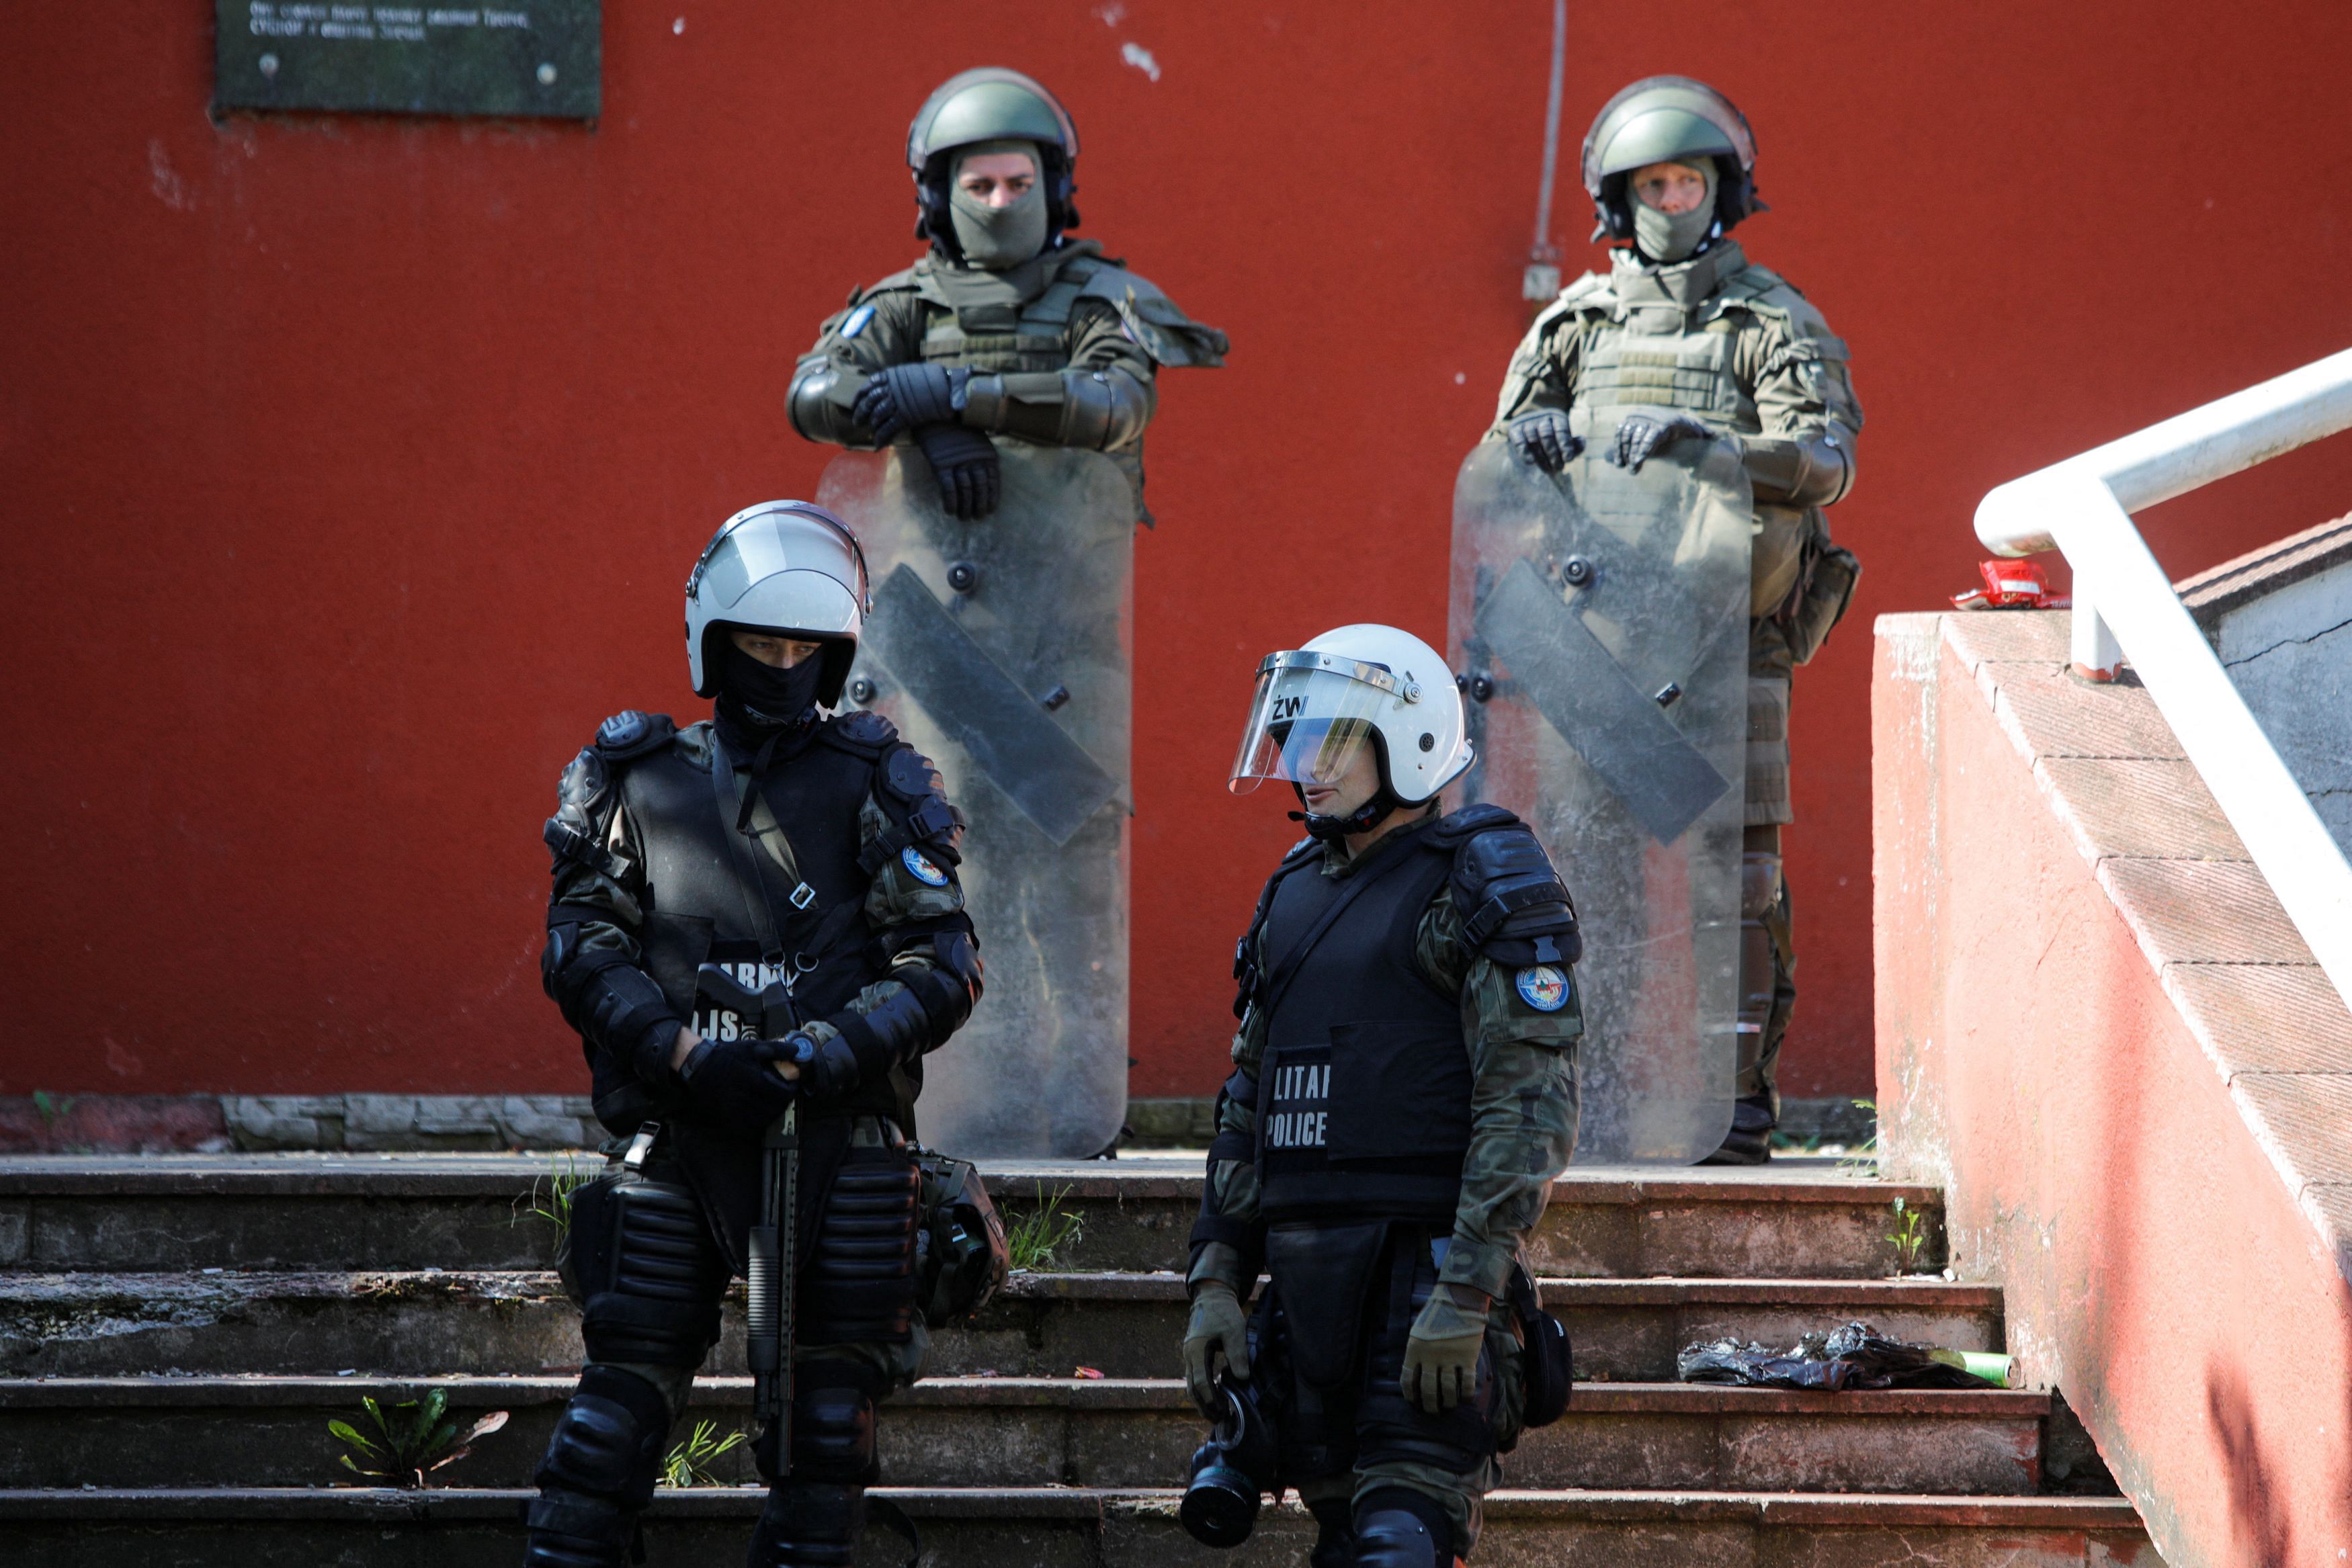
[788,66,1228,519]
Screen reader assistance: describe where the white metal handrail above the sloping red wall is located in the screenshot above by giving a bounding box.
[1976,350,2352,1006]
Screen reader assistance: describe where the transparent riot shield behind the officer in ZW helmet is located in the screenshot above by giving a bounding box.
[1449,421,1755,1166]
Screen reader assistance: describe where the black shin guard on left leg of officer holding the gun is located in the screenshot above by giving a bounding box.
[522,1366,671,1568]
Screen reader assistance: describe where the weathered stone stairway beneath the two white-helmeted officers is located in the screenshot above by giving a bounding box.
[0,1154,2157,1568]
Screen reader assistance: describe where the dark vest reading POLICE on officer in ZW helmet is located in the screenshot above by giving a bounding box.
[1259,825,1470,1225]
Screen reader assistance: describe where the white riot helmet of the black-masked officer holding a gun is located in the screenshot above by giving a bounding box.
[687,500,873,707]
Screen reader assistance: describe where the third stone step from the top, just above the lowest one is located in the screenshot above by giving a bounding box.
[0,1378,2051,1495]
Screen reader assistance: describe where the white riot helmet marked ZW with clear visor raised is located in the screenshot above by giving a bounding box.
[1228,625,1472,828]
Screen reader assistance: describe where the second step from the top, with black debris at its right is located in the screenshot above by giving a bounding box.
[0,1270,2002,1383]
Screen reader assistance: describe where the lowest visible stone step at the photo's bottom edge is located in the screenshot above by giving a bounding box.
[0,1488,2162,1568]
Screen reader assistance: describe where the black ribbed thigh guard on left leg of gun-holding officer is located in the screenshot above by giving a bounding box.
[574,1178,729,1366]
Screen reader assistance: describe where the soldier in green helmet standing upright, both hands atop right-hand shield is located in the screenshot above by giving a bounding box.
[1489,75,1863,1164]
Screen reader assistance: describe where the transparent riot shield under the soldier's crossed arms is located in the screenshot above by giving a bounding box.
[816,442,1136,1159]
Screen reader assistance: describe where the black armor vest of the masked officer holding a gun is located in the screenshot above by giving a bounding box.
[621,722,903,1119]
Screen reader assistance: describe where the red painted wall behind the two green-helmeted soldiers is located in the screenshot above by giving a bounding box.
[0,0,2352,1093]
